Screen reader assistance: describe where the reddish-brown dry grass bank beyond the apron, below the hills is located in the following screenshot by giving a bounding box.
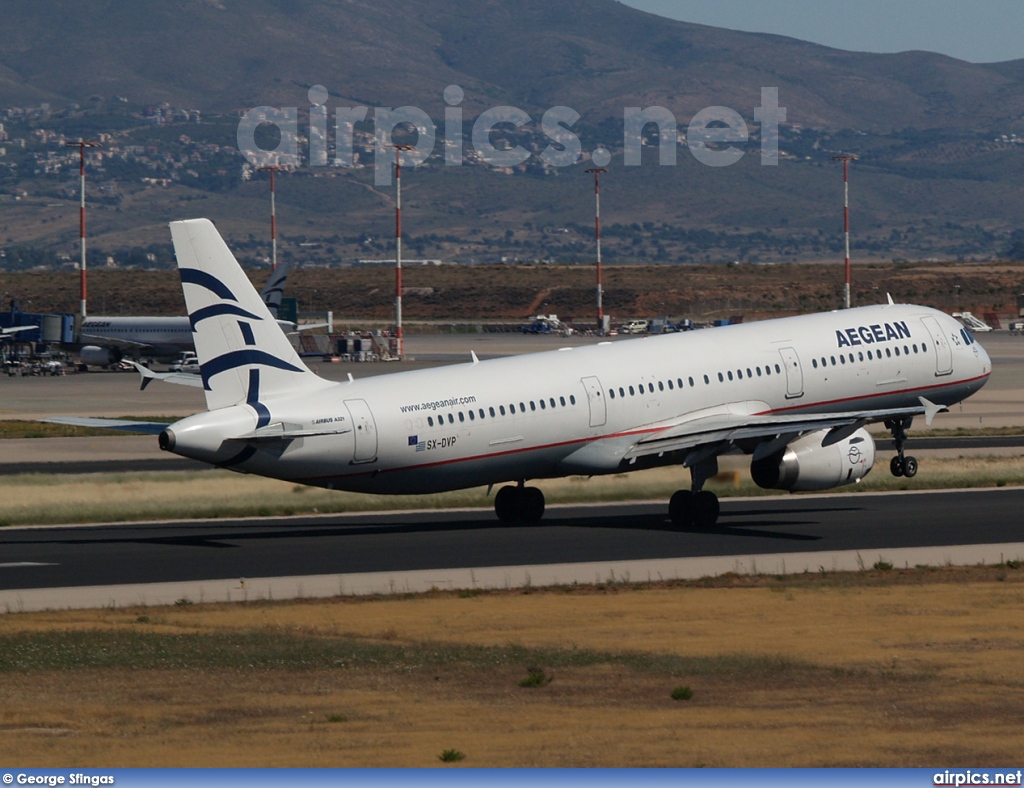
[0,257,1021,324]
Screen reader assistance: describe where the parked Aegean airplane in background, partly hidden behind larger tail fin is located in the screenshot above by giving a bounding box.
[71,261,296,366]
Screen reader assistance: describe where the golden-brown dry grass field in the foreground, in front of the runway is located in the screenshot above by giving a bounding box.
[0,564,1024,768]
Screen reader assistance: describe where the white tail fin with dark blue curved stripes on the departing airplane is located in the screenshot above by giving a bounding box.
[171,219,330,411]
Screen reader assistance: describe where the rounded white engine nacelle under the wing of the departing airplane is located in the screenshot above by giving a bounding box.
[751,429,874,492]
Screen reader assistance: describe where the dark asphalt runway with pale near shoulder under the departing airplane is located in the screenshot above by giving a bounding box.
[0,488,1024,610]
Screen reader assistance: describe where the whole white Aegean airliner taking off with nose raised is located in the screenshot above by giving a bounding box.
[48,219,992,530]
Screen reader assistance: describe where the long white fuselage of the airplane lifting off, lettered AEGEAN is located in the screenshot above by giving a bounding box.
[167,305,991,493]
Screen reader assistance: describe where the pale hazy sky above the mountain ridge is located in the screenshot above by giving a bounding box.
[622,0,1024,62]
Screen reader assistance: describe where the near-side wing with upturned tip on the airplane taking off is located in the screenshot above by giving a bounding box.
[624,397,947,459]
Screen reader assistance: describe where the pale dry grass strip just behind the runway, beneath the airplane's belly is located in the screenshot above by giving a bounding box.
[0,456,1024,526]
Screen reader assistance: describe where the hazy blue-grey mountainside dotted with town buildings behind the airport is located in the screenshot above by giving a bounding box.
[0,0,1024,266]
